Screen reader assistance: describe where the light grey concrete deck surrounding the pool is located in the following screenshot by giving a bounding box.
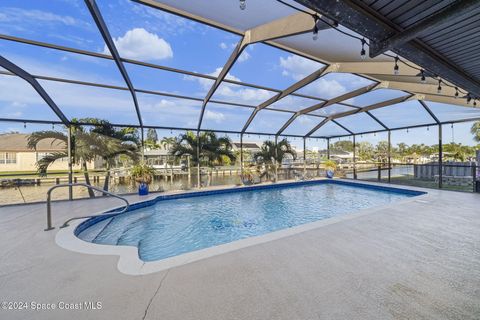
[0,179,480,320]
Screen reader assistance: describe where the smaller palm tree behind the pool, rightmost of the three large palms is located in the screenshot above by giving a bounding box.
[253,139,297,180]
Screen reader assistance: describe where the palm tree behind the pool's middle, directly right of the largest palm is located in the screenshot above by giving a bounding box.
[170,131,236,185]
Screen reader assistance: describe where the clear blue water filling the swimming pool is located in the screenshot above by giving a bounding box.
[77,182,419,261]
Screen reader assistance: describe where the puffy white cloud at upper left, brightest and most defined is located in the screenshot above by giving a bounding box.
[103,28,173,60]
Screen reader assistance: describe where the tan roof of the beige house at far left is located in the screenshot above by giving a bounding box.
[0,133,65,152]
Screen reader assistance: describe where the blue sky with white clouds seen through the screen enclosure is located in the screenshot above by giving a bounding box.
[0,0,480,144]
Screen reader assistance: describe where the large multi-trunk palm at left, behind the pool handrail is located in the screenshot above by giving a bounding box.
[27,118,138,198]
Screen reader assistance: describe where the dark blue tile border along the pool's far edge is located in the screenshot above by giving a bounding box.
[74,179,427,236]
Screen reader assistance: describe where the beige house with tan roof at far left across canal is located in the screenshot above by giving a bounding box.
[0,133,95,172]
